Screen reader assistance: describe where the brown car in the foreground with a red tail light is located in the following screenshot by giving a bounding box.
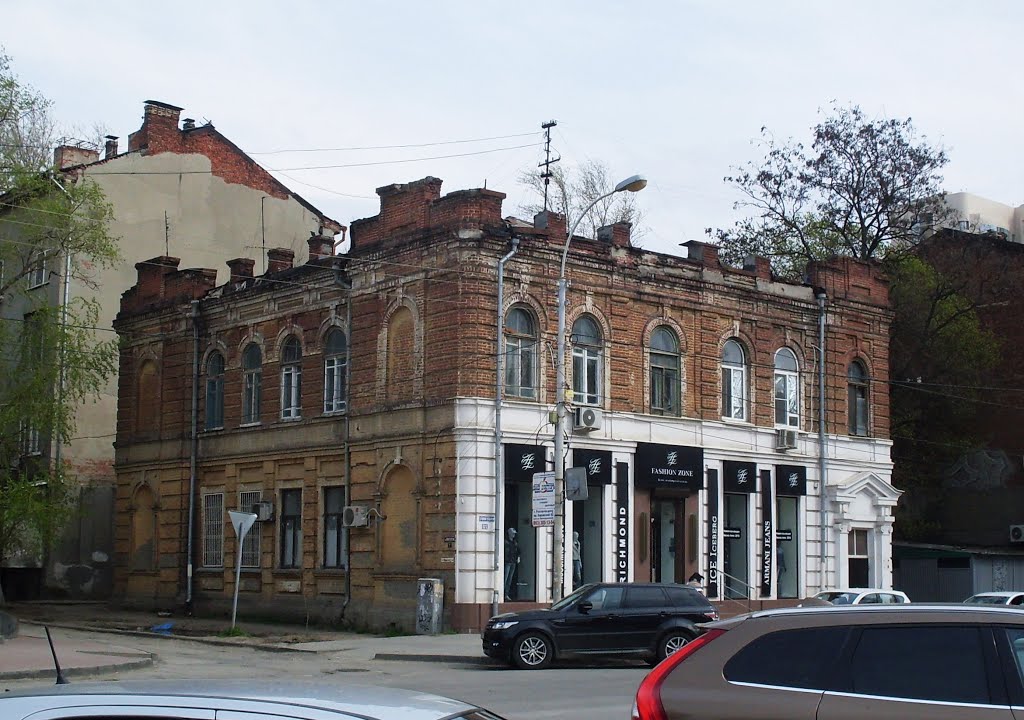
[633,604,1024,720]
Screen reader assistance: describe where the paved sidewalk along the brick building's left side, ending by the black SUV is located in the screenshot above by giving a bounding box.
[0,603,490,679]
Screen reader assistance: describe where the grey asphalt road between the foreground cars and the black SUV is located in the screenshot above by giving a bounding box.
[3,631,649,720]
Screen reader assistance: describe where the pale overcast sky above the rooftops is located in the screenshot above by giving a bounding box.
[0,0,1024,259]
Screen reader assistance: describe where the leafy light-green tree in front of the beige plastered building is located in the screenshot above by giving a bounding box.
[0,55,120,601]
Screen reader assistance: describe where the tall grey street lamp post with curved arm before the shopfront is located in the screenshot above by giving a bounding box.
[551,175,647,601]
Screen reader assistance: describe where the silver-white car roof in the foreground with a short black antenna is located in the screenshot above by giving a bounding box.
[0,680,501,720]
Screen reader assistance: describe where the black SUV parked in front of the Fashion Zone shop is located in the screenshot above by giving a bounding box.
[483,583,718,670]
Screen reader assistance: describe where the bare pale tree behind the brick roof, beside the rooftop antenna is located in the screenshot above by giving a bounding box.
[518,160,643,240]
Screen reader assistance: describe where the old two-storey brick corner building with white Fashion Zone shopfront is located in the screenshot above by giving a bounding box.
[110,177,898,629]
